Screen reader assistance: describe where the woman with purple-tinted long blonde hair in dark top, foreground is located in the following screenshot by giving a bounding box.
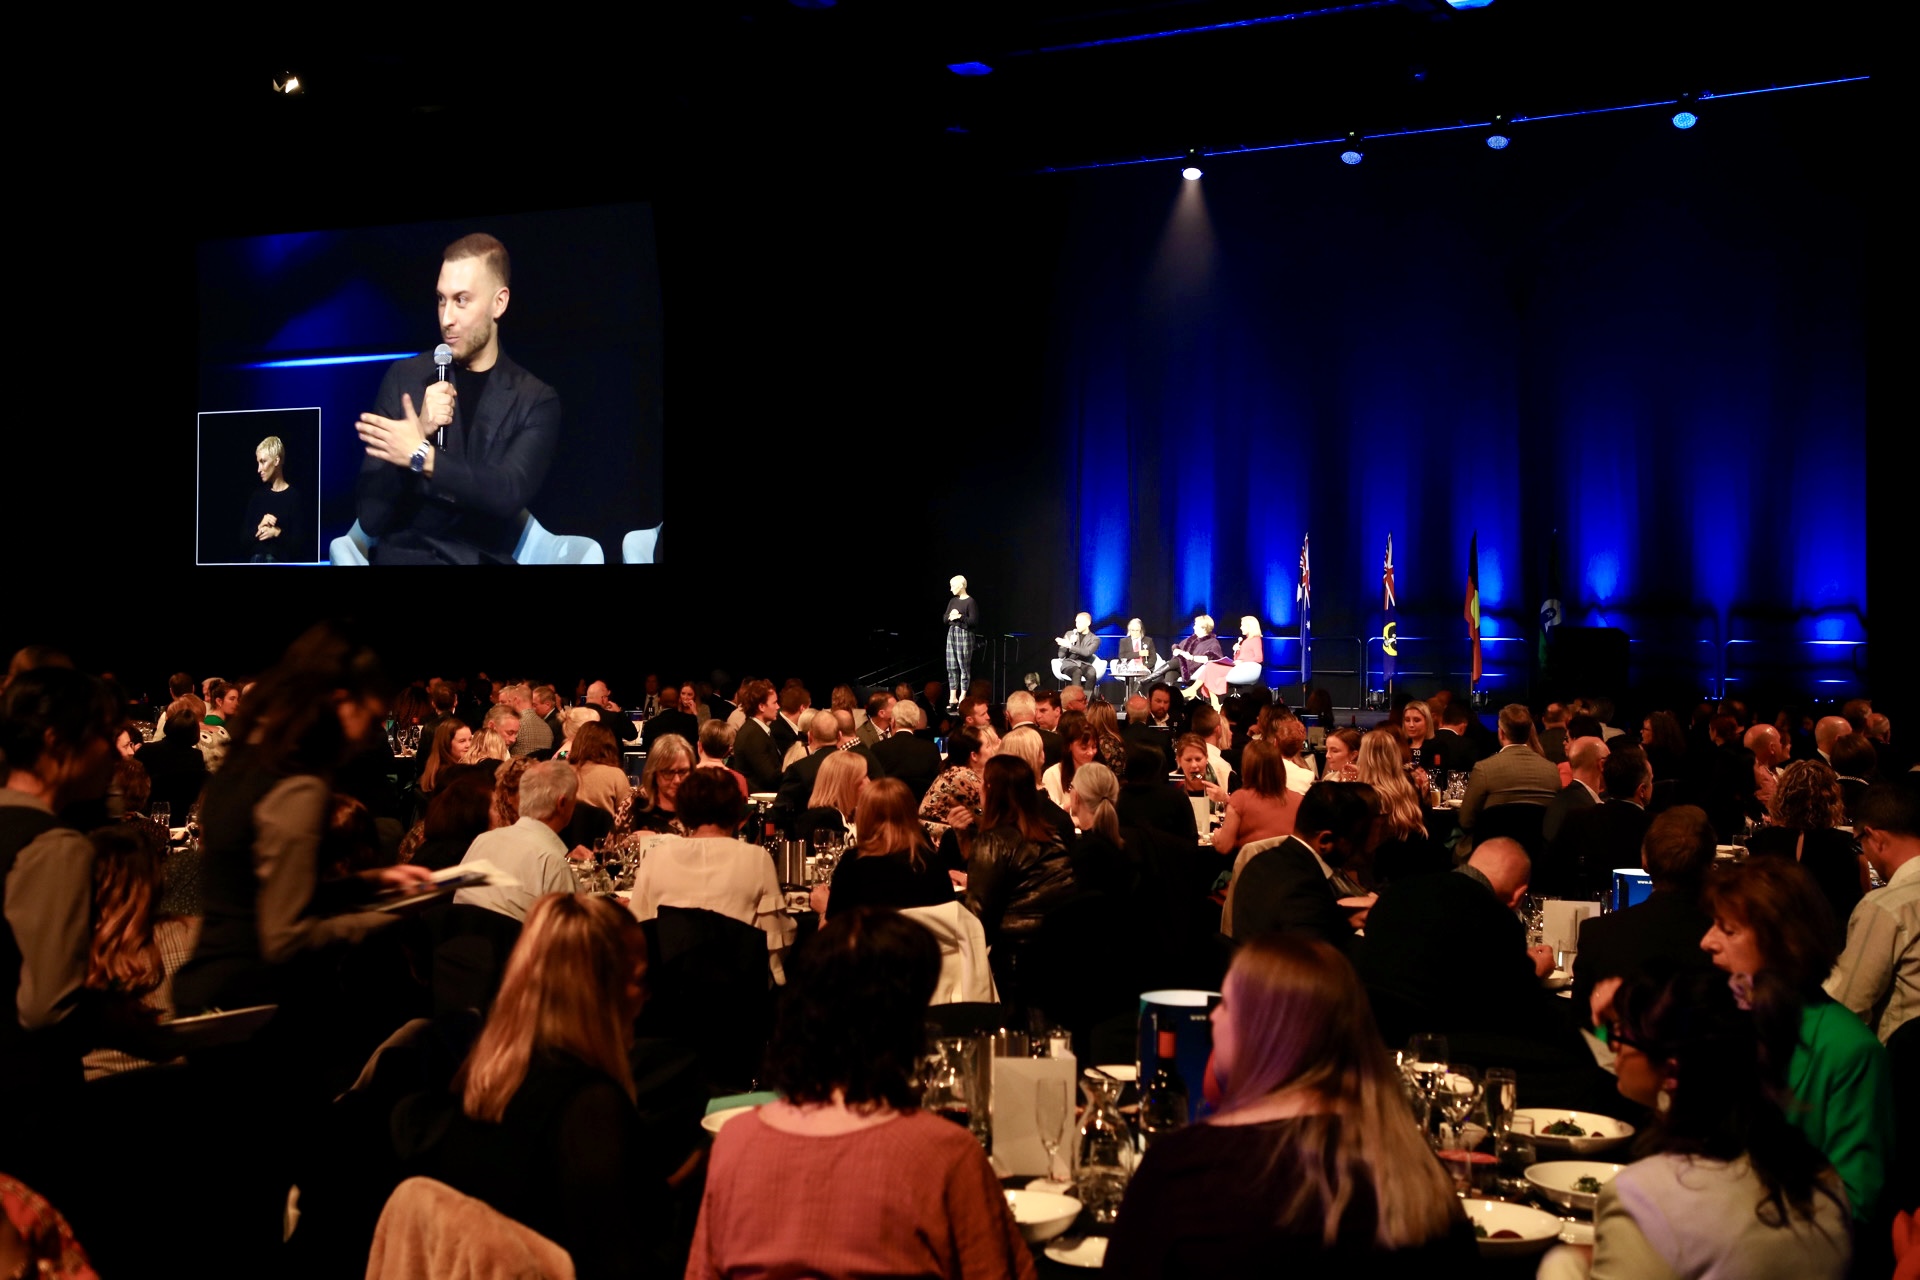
[1106,935,1476,1278]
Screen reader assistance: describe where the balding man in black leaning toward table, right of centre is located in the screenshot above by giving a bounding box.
[1357,839,1594,1107]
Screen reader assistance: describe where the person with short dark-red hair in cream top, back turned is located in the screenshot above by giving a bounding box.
[630,770,793,979]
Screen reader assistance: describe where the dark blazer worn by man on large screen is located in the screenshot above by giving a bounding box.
[359,351,561,564]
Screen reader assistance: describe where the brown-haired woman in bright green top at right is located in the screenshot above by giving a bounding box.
[1699,858,1893,1222]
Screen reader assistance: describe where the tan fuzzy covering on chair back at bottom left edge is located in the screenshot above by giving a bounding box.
[367,1178,574,1280]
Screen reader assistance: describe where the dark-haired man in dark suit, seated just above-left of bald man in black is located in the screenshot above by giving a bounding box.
[1225,783,1379,950]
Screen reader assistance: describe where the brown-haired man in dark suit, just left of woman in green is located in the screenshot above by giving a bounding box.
[1572,804,1713,1021]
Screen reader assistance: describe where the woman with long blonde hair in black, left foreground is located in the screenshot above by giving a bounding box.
[394,894,670,1276]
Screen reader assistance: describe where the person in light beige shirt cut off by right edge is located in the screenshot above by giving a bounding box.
[1826,775,1920,1043]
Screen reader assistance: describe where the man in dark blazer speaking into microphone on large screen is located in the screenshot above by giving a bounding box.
[357,234,561,564]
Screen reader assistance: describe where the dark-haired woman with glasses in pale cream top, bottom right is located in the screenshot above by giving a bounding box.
[1540,969,1850,1280]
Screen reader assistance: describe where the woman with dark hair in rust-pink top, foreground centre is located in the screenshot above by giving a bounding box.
[687,908,1033,1280]
